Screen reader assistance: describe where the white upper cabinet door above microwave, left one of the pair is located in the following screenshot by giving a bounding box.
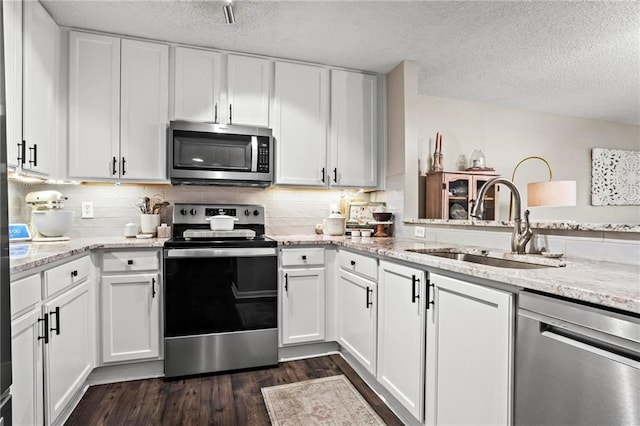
[173,47,222,122]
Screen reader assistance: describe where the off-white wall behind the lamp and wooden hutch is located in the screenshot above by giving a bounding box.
[416,95,640,223]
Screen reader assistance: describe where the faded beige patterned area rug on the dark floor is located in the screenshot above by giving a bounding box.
[261,375,385,426]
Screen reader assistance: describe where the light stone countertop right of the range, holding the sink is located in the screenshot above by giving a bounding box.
[271,235,640,314]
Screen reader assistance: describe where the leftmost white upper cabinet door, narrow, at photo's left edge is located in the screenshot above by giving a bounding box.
[2,1,22,170]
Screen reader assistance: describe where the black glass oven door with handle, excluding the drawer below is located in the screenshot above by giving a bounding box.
[164,247,278,337]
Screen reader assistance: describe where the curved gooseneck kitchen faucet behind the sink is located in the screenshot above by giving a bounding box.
[471,177,533,254]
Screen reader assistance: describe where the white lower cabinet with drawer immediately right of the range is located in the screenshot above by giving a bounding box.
[280,247,325,345]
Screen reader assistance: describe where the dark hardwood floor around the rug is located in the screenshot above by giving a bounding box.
[65,355,402,426]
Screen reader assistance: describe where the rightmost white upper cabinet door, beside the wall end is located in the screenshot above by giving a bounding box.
[329,70,378,188]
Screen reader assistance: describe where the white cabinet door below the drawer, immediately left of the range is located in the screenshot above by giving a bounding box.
[101,274,161,362]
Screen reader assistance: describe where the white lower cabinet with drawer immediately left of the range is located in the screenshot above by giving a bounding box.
[100,249,162,363]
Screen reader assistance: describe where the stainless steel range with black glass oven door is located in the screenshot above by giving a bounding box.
[163,203,278,378]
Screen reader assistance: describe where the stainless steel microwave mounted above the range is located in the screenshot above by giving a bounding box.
[168,120,273,187]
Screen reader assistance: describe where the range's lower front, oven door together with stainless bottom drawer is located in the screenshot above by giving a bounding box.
[164,247,278,377]
